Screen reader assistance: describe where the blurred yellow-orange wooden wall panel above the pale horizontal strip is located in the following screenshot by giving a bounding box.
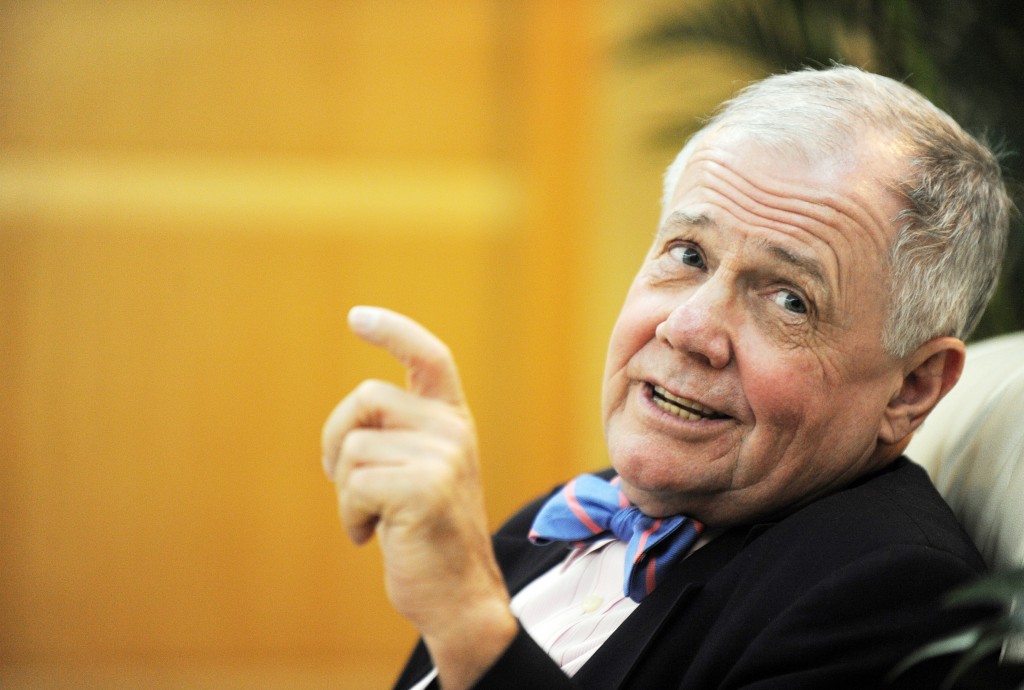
[0,0,506,159]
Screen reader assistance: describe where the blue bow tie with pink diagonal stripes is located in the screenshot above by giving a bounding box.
[529,474,703,602]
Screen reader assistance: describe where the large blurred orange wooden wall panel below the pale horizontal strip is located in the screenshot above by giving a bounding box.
[2,211,569,675]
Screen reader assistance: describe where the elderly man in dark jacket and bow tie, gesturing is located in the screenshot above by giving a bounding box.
[323,68,1010,690]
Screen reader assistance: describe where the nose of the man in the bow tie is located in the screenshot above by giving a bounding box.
[654,279,732,369]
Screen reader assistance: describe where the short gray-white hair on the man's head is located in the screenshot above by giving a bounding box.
[662,66,1012,357]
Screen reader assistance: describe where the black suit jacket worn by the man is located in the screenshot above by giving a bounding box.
[395,459,985,690]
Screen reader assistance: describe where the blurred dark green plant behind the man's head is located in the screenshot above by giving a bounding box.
[629,0,1024,339]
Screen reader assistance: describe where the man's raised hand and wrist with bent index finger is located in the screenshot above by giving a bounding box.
[322,307,517,690]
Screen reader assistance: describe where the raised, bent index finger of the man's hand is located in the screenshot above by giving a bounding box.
[348,306,464,404]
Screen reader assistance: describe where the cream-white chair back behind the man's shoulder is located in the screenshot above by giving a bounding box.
[906,333,1024,660]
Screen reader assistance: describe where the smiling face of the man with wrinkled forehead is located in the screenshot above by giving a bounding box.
[603,131,902,525]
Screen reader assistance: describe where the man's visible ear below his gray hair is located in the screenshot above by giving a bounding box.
[879,337,966,445]
